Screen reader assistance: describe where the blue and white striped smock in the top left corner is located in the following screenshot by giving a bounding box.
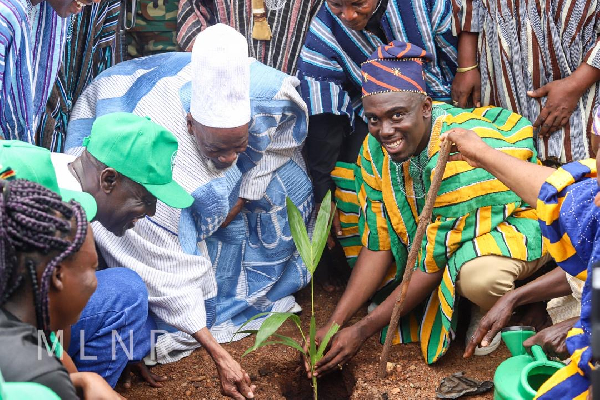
[0,0,69,144]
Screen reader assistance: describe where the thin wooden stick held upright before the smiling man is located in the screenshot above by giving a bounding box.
[379,140,452,378]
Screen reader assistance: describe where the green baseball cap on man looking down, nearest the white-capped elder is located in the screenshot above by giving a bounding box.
[83,112,194,208]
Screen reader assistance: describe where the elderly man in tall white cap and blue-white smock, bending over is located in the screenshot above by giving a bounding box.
[66,24,313,399]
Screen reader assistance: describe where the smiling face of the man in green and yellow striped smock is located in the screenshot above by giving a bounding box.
[363,92,432,162]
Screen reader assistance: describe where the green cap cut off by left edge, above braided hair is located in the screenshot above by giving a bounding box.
[0,140,98,221]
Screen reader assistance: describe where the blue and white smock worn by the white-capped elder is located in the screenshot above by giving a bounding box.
[66,53,314,362]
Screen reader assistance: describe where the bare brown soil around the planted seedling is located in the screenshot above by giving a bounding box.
[117,285,509,400]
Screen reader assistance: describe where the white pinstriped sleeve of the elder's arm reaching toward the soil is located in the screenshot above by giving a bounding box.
[93,202,217,335]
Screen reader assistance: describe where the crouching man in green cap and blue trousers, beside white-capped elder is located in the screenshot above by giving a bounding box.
[47,113,193,387]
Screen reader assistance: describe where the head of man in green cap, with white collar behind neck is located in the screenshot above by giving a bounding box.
[52,112,193,236]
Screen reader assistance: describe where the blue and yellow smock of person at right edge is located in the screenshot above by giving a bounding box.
[536,159,600,400]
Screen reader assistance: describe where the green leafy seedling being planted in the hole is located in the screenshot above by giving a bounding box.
[234,192,340,399]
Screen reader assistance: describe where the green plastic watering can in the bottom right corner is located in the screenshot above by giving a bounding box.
[494,326,564,400]
